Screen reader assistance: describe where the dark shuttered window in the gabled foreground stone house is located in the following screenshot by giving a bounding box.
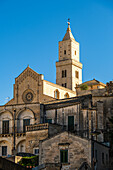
[60,150,68,163]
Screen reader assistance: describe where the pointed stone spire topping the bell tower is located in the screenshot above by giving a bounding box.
[63,18,75,41]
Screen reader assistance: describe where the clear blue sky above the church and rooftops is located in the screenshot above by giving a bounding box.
[0,0,113,105]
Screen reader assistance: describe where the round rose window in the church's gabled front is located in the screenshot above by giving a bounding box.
[22,89,34,103]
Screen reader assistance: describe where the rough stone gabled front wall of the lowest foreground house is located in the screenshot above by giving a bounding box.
[39,132,91,169]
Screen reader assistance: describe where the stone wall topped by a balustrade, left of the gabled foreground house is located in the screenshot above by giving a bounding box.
[26,123,62,153]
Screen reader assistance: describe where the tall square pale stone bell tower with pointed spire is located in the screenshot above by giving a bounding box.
[56,19,82,91]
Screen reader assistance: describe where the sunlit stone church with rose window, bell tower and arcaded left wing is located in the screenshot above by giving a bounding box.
[0,20,82,156]
